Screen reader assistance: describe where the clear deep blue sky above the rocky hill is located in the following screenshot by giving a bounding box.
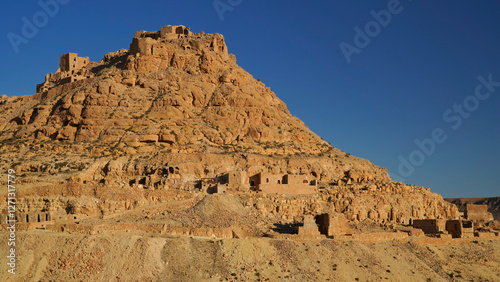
[0,0,500,197]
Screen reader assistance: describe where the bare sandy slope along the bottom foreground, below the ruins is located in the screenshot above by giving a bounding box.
[0,230,500,281]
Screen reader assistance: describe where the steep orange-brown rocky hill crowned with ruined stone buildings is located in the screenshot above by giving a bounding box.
[0,26,458,226]
